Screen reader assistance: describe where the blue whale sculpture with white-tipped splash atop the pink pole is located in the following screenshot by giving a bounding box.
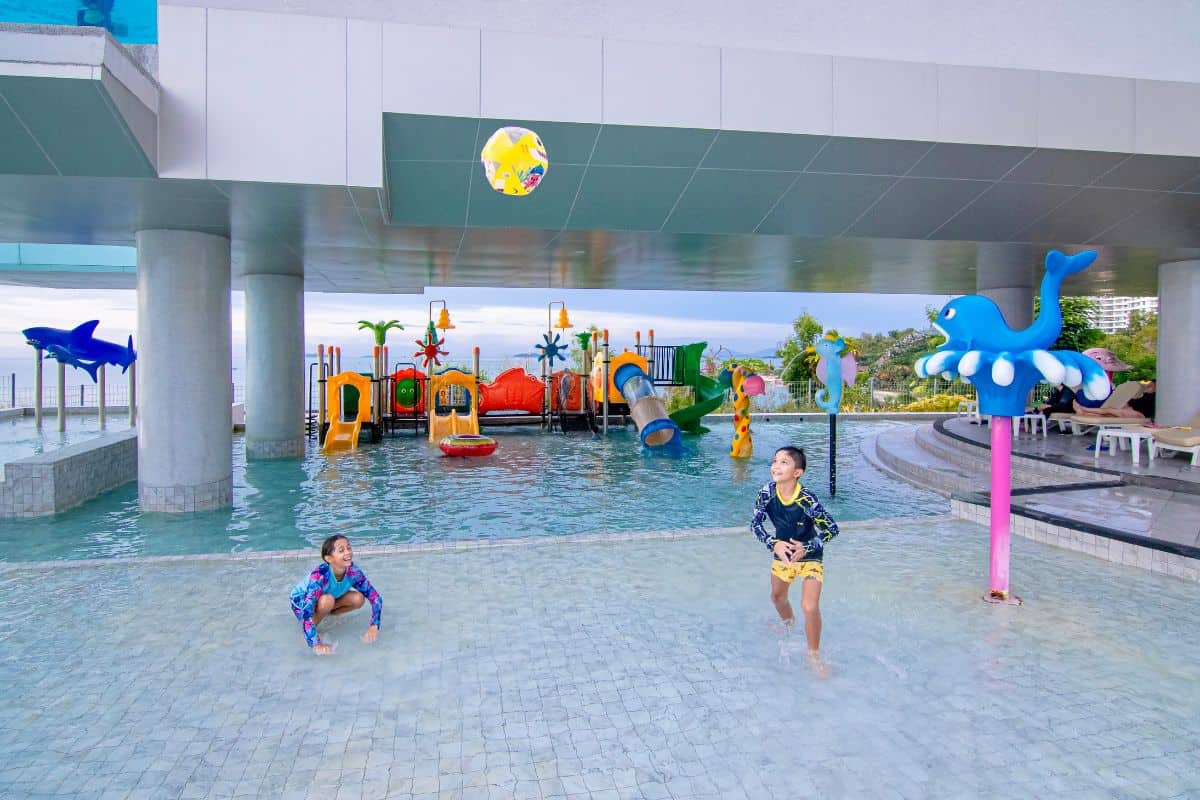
[913,249,1112,416]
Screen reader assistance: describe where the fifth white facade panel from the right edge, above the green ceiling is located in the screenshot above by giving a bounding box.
[721,48,833,134]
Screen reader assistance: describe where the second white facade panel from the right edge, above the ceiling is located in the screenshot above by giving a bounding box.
[1038,72,1134,152]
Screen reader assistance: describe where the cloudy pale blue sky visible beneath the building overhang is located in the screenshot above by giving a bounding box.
[0,285,949,385]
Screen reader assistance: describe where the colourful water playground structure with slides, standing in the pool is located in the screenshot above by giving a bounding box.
[308,303,761,457]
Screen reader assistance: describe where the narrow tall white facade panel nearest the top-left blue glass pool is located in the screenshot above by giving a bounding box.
[158,6,209,178]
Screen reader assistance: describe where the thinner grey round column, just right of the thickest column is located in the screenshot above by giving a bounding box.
[245,275,305,458]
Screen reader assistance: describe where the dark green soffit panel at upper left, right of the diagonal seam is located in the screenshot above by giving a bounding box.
[0,77,155,178]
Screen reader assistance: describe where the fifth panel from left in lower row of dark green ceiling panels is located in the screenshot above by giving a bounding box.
[757,173,895,236]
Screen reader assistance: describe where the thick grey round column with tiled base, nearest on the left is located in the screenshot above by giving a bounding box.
[137,230,233,511]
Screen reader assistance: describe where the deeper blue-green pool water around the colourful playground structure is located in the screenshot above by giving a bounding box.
[0,421,949,561]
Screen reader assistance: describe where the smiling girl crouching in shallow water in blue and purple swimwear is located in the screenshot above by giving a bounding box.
[292,534,383,656]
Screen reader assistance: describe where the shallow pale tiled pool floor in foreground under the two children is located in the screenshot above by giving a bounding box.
[0,517,1200,800]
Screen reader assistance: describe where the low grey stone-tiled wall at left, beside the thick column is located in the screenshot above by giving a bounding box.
[0,431,138,518]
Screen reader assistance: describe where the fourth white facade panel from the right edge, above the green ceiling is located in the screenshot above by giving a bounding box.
[833,59,937,140]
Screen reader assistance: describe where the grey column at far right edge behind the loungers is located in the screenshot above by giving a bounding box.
[1154,261,1200,425]
